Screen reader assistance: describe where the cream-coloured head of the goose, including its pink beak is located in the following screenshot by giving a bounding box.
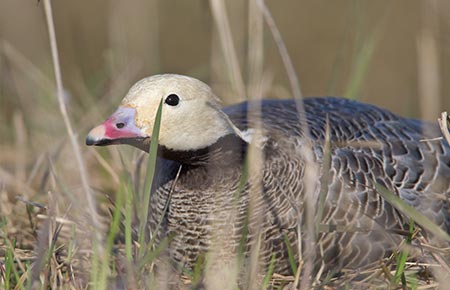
[86,74,242,151]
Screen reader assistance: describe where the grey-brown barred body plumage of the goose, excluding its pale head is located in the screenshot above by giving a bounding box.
[150,98,450,274]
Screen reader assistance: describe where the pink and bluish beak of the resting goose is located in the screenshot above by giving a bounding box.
[86,107,150,150]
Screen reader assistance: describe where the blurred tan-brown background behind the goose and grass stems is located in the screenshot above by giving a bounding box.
[0,0,450,244]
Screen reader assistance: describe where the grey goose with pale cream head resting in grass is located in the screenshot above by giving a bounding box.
[86,74,450,275]
